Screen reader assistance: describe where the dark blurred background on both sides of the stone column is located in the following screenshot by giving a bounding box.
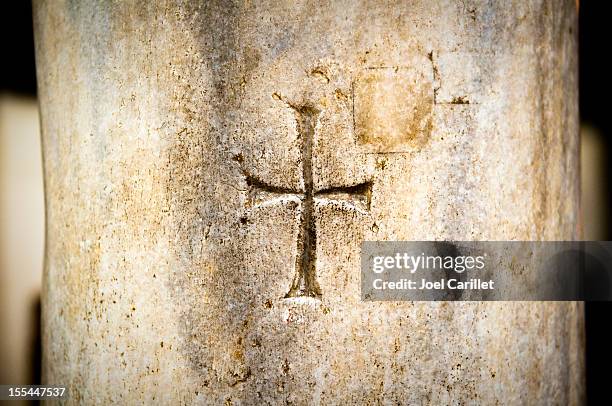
[0,0,612,404]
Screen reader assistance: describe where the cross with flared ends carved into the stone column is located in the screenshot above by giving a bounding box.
[247,105,372,298]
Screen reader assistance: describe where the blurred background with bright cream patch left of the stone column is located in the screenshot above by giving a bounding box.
[0,0,44,403]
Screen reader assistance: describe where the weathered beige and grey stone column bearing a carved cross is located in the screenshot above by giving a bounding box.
[34,0,584,404]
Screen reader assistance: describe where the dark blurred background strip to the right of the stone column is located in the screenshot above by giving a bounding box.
[579,0,612,404]
